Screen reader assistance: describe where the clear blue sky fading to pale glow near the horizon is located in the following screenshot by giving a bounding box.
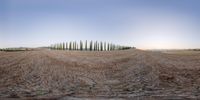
[0,0,200,49]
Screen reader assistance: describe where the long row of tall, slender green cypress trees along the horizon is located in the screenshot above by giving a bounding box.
[50,40,131,51]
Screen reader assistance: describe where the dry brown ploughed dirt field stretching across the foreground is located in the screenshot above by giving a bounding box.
[0,49,200,100]
